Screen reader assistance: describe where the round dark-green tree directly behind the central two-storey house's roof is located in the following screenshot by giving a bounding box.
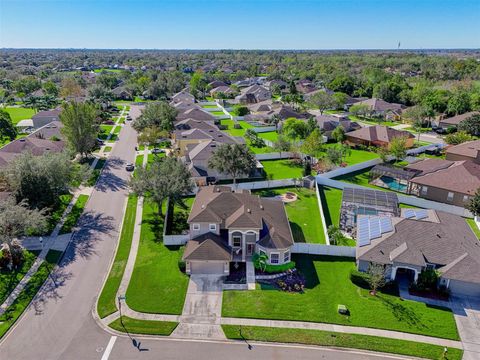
[208,144,257,185]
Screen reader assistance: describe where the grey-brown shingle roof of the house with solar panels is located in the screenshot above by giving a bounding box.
[357,210,480,283]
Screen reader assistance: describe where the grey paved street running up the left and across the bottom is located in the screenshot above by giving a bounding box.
[0,105,412,360]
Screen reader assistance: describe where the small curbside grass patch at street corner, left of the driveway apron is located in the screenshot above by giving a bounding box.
[108,316,178,336]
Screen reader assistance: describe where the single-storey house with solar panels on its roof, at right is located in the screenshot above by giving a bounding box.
[356,209,480,297]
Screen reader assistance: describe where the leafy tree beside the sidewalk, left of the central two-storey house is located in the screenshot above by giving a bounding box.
[130,156,193,216]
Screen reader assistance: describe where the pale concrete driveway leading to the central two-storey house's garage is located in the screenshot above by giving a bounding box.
[173,275,225,339]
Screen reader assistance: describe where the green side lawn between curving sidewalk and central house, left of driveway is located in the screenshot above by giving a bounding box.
[126,200,188,314]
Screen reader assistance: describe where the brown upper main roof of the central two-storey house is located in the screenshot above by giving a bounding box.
[188,186,293,249]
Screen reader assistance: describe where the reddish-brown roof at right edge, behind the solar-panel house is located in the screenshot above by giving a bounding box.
[410,159,480,196]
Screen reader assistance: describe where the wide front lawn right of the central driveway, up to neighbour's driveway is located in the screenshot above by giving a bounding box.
[222,255,459,340]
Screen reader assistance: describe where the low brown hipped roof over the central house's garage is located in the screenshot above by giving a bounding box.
[183,233,232,261]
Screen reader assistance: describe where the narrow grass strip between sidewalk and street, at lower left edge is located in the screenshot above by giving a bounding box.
[0,250,62,338]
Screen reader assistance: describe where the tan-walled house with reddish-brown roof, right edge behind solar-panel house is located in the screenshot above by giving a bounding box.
[406,159,480,207]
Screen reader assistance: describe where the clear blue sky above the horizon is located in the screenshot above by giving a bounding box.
[0,0,480,49]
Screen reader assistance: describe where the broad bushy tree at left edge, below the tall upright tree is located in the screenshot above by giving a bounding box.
[0,151,84,209]
